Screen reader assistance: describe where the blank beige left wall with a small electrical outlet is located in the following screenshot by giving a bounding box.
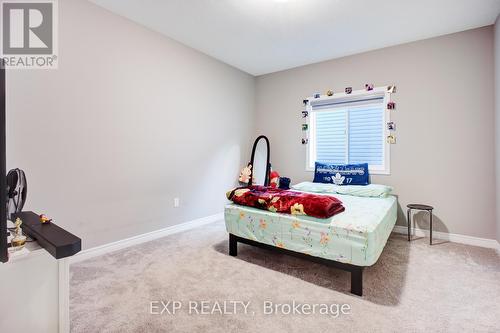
[7,0,255,248]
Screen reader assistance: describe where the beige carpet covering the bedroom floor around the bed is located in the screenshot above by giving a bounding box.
[70,222,500,333]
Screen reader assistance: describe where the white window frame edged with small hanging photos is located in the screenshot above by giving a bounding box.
[306,86,391,175]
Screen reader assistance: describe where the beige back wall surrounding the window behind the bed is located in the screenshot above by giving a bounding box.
[256,26,496,238]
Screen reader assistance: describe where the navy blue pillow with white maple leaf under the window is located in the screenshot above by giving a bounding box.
[313,162,370,185]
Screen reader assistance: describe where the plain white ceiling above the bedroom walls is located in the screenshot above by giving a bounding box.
[90,0,500,75]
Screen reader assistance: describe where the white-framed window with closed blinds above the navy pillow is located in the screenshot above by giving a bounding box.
[307,88,390,174]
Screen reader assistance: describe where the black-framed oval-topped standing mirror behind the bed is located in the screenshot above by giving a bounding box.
[248,135,271,186]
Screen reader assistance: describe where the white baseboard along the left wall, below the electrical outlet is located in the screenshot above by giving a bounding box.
[70,213,224,263]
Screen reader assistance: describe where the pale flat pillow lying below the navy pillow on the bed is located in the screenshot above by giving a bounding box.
[292,182,392,198]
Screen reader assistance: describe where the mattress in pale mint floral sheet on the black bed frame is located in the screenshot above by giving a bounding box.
[224,194,397,266]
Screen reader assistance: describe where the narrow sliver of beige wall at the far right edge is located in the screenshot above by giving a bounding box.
[494,15,500,242]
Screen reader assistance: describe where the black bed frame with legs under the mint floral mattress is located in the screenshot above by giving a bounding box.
[229,233,364,296]
